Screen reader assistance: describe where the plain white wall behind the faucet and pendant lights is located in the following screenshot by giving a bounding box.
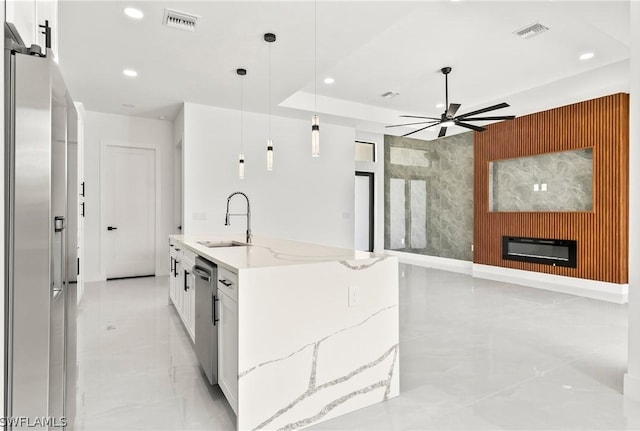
[183,103,355,248]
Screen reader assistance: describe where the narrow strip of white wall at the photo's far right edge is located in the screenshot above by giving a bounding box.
[624,1,640,401]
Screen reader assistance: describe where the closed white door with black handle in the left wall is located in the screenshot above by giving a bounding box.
[104,145,156,279]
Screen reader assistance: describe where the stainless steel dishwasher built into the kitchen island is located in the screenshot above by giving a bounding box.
[192,256,218,385]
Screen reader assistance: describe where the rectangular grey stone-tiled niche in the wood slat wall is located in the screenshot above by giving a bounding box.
[489,148,593,212]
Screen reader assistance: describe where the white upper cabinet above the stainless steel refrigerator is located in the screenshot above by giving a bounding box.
[5,0,58,55]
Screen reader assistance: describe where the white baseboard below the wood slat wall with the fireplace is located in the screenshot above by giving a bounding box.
[472,263,629,304]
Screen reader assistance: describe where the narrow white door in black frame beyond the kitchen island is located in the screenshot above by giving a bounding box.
[354,172,373,251]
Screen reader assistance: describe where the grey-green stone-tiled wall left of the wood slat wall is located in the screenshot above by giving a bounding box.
[384,133,473,261]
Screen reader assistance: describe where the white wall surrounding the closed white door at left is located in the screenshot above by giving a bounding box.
[84,111,174,281]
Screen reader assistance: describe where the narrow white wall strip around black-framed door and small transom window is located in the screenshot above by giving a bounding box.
[355,132,384,252]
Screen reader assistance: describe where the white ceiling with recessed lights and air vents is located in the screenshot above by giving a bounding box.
[59,0,630,139]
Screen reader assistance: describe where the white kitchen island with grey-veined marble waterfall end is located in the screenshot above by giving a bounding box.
[170,235,399,430]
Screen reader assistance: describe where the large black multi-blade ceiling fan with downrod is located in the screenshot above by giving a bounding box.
[385,67,516,138]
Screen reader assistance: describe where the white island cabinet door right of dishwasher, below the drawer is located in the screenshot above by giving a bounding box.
[218,283,238,414]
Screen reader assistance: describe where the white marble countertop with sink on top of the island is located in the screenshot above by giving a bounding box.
[169,234,383,270]
